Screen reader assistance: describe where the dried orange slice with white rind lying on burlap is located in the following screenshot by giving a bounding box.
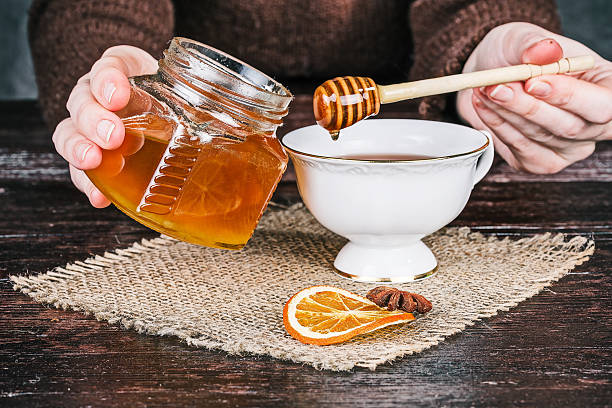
[283,286,414,346]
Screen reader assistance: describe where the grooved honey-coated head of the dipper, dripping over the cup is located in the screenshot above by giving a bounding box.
[313,76,380,140]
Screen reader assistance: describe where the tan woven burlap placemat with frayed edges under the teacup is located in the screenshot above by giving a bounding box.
[11,205,594,370]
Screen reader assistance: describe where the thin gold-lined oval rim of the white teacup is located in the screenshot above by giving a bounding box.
[279,119,491,164]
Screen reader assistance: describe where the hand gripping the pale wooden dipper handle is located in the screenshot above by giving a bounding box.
[457,23,612,174]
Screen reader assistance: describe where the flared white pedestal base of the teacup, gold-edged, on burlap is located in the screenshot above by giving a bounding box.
[334,240,438,283]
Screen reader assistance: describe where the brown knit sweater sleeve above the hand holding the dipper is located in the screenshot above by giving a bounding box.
[409,0,561,119]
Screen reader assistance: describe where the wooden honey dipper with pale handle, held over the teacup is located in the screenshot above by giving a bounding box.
[313,55,595,140]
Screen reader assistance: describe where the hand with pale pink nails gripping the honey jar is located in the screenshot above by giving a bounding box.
[53,45,157,208]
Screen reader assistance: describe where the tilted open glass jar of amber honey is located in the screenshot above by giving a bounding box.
[86,37,292,249]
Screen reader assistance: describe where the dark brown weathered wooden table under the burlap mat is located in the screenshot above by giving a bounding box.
[0,99,612,407]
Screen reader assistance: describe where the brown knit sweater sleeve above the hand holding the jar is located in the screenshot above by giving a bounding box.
[28,0,174,127]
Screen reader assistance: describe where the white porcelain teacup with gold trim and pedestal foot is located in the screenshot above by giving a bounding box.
[281,119,493,282]
